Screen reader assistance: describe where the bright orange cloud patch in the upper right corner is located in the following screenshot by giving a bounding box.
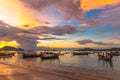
[81,0,120,11]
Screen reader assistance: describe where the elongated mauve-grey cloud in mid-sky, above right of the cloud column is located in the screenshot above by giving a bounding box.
[31,25,79,36]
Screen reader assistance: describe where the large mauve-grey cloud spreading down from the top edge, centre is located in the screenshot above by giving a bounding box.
[19,0,101,26]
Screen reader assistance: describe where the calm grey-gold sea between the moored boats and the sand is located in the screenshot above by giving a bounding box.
[0,51,120,73]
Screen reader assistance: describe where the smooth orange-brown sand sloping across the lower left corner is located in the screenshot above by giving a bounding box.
[0,64,74,80]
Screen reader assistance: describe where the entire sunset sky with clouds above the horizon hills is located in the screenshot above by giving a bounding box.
[0,0,120,49]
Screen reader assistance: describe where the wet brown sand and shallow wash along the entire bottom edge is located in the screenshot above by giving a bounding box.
[0,64,120,80]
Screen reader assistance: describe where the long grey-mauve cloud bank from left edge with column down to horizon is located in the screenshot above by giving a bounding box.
[0,21,79,50]
